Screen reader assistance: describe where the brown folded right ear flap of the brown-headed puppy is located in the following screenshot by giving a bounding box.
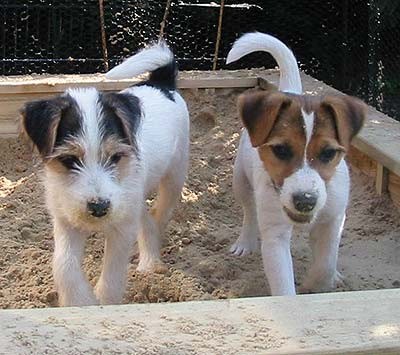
[320,95,367,150]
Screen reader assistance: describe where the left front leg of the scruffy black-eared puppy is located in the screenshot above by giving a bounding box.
[53,218,98,306]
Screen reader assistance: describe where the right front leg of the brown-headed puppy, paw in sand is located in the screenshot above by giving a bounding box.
[300,215,345,292]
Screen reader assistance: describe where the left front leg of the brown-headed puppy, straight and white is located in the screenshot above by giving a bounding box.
[260,225,296,296]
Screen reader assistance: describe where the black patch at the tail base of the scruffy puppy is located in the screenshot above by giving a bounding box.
[133,59,178,102]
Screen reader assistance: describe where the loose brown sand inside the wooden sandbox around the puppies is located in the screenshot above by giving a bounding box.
[0,90,400,308]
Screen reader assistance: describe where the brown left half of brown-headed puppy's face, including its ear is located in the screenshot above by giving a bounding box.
[239,92,306,187]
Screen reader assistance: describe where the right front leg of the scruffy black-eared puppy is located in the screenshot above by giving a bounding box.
[95,222,137,304]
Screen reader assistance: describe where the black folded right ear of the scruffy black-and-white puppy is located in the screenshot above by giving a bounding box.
[101,93,141,146]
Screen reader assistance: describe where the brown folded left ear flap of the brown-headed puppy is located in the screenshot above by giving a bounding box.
[238,91,291,147]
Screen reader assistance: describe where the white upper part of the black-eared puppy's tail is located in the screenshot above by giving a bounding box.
[106,42,174,79]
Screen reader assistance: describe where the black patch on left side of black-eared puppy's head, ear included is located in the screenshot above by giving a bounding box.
[21,95,81,157]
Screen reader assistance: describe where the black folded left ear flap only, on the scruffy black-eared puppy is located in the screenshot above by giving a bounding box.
[20,96,71,159]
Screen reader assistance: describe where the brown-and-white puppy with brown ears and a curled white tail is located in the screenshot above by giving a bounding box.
[227,33,366,295]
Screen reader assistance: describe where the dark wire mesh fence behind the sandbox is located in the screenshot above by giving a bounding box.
[0,0,400,120]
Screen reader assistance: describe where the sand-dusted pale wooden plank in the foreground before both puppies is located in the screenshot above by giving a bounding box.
[0,290,400,355]
